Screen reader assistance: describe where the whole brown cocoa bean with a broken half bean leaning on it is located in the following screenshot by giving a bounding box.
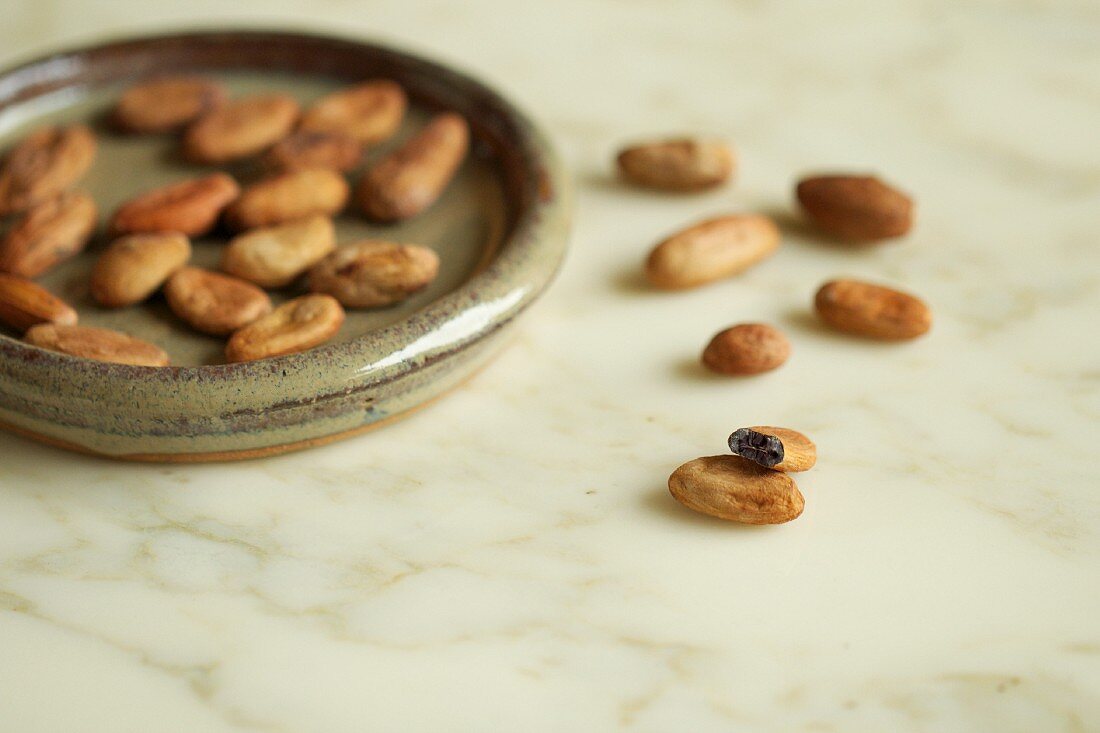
[669,456,805,524]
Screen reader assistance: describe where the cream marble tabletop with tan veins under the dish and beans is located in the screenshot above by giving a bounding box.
[0,0,1100,733]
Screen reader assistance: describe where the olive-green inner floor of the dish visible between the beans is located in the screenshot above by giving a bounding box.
[0,73,507,365]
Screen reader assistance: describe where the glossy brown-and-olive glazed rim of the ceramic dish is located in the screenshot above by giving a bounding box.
[0,29,569,415]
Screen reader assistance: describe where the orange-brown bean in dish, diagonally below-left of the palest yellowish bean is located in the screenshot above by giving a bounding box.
[164,267,272,336]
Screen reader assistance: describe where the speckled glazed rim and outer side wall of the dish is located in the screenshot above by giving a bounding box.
[0,32,569,460]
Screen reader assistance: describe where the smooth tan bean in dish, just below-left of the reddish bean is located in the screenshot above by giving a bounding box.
[91,232,191,308]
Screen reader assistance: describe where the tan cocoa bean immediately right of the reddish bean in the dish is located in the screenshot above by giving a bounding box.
[226,168,348,231]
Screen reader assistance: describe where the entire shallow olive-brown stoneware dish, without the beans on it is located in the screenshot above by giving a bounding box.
[0,31,569,460]
